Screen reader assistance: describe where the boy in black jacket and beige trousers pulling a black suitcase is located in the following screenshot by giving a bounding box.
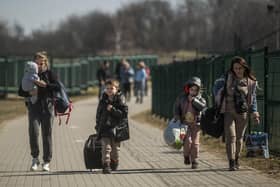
[95,80,128,173]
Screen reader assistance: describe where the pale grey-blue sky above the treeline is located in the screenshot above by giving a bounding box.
[0,0,184,34]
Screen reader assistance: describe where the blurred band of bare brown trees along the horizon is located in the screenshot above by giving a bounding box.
[0,0,279,56]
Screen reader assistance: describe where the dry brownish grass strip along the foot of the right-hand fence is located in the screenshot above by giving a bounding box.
[132,110,280,180]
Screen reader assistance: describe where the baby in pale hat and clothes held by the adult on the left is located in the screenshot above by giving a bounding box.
[21,61,40,104]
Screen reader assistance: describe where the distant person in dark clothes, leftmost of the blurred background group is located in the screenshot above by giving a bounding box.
[96,61,112,99]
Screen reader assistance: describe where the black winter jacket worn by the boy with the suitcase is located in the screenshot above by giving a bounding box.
[95,91,128,137]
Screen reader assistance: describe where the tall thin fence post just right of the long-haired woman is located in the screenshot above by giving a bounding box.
[263,47,269,133]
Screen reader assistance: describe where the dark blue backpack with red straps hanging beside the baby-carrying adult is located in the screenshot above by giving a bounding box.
[54,81,73,125]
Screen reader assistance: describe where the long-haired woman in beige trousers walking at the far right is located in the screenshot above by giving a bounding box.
[213,56,260,171]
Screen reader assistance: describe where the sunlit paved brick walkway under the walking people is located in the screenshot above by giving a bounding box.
[0,94,280,187]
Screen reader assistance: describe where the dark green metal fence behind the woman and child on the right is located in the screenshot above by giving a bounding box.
[151,49,280,153]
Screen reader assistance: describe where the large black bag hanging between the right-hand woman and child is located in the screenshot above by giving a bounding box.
[200,106,224,138]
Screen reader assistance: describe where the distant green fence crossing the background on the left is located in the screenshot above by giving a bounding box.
[0,55,157,96]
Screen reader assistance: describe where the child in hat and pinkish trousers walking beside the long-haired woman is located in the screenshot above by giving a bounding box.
[174,77,206,169]
